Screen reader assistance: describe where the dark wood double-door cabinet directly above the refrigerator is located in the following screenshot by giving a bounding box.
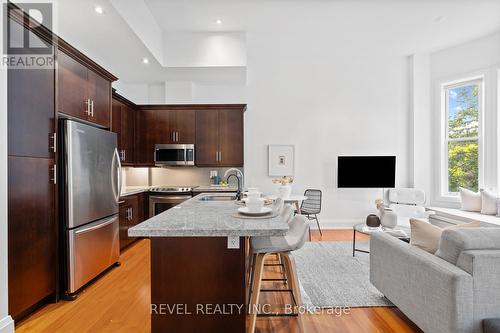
[56,48,116,128]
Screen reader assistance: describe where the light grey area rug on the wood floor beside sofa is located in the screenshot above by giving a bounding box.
[293,241,393,308]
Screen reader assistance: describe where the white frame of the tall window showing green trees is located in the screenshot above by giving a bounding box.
[438,75,485,202]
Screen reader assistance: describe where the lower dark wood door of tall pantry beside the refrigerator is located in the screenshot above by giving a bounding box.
[8,156,57,320]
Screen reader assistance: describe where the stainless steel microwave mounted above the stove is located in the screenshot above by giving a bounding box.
[155,144,194,166]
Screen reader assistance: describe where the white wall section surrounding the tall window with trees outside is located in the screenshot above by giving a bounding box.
[423,32,500,207]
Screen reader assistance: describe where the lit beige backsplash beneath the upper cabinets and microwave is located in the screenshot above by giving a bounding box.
[123,167,241,186]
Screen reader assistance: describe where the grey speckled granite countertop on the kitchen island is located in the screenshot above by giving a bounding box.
[128,193,288,237]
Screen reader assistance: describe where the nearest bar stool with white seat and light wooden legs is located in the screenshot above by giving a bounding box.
[248,215,309,333]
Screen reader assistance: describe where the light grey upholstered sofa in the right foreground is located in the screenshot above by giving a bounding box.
[370,228,500,333]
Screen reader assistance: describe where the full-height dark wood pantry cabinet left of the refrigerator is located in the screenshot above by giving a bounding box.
[7,7,58,321]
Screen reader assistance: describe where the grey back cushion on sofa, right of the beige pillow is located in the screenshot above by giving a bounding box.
[436,228,500,265]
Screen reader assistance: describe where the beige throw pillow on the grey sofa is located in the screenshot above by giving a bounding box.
[410,219,480,254]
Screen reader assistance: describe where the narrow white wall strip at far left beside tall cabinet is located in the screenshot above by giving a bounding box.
[0,5,14,333]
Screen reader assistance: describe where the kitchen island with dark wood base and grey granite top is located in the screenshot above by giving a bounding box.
[128,193,288,333]
